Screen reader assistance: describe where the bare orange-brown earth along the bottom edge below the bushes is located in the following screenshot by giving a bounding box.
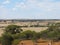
[18,40,60,45]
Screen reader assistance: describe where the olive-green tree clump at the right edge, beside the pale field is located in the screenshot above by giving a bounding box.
[41,23,60,40]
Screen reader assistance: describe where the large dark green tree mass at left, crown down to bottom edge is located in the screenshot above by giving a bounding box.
[1,25,22,45]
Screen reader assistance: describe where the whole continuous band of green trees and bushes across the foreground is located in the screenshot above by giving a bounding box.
[0,23,60,45]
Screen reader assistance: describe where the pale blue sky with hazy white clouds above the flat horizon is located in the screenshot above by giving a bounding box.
[0,0,60,19]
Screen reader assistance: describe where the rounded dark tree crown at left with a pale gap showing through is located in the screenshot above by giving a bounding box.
[5,25,22,34]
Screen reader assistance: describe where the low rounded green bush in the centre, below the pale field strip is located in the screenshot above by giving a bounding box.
[20,30,40,40]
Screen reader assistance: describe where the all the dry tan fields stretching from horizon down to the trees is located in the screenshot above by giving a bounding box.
[0,20,60,36]
